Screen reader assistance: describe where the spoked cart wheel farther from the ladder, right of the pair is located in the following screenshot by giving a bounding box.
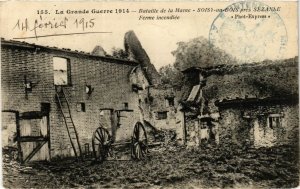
[131,122,148,160]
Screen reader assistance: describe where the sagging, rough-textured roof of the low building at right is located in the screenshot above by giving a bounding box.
[181,57,298,103]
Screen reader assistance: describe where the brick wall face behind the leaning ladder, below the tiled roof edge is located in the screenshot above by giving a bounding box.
[1,42,143,157]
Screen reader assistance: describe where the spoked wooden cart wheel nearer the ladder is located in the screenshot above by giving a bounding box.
[92,127,112,162]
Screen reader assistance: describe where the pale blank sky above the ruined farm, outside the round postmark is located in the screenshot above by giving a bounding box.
[1,2,298,68]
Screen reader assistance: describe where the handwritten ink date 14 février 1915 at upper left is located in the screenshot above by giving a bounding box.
[13,15,96,38]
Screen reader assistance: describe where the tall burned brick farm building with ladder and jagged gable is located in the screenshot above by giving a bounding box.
[1,32,182,162]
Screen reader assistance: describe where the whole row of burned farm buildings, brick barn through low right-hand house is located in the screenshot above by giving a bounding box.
[1,31,299,165]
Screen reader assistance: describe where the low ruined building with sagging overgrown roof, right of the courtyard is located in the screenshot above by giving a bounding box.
[182,57,299,147]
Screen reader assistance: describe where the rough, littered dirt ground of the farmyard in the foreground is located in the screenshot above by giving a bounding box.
[3,142,299,188]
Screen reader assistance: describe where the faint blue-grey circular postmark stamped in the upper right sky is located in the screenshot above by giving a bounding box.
[209,1,288,62]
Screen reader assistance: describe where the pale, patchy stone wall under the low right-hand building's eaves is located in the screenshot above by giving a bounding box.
[219,104,299,147]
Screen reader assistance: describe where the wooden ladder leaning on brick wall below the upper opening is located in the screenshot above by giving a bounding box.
[55,87,83,160]
